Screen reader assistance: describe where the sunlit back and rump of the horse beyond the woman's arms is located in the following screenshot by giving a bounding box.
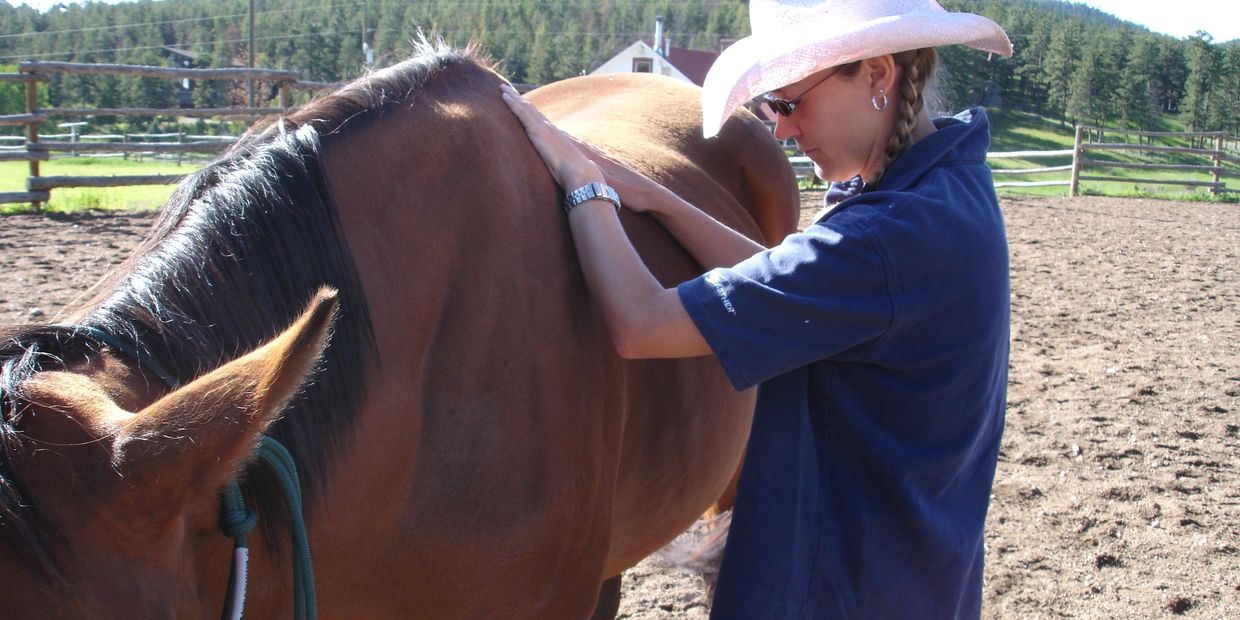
[527,73,800,261]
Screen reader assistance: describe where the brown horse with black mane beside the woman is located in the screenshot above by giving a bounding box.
[0,42,797,619]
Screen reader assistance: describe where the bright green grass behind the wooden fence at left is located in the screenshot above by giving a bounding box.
[0,157,206,215]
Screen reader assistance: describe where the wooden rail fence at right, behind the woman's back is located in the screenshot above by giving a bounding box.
[987,125,1240,196]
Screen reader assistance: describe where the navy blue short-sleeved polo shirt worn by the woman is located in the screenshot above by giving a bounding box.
[680,109,1009,620]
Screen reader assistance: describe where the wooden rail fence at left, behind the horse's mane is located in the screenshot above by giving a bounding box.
[0,62,336,208]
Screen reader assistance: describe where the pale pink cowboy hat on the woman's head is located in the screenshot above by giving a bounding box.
[702,0,1012,138]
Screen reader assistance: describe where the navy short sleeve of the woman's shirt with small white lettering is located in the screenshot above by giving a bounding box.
[678,218,893,389]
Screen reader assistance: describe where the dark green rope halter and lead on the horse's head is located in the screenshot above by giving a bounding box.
[57,325,319,620]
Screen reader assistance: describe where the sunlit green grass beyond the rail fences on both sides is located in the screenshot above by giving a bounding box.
[0,110,1240,215]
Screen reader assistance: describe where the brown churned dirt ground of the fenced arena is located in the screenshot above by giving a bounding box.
[0,192,1240,619]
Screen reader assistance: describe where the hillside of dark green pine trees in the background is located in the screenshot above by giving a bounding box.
[0,0,1240,133]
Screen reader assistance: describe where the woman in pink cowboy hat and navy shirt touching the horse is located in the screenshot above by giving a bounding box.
[503,0,1012,620]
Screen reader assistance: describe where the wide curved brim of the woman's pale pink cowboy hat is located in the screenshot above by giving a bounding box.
[702,11,1012,138]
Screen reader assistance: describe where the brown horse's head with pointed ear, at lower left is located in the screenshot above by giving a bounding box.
[0,291,336,618]
